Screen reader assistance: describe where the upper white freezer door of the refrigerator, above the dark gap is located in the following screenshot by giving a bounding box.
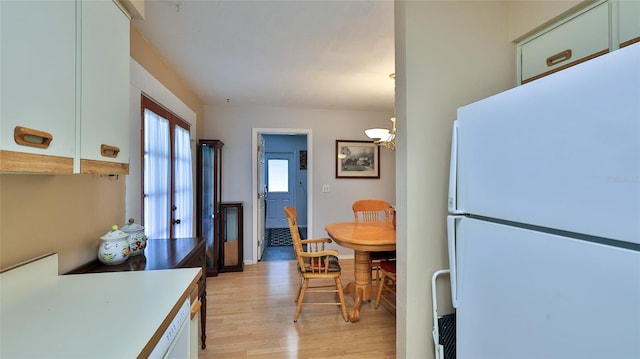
[456,43,640,243]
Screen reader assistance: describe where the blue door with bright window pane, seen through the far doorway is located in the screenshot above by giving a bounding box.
[265,152,295,228]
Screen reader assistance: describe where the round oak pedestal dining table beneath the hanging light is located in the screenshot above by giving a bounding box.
[325,222,396,322]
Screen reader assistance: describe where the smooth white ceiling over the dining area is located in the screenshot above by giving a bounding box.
[133,0,395,113]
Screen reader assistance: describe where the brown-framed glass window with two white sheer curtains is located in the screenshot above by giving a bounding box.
[142,95,194,238]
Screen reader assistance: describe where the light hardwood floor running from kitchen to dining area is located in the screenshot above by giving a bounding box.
[199,260,396,359]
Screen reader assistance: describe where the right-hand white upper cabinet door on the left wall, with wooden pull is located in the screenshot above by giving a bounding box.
[80,0,129,174]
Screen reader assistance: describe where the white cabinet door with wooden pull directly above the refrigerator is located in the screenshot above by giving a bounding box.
[520,3,609,83]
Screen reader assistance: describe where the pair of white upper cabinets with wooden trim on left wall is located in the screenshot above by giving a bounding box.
[0,0,129,174]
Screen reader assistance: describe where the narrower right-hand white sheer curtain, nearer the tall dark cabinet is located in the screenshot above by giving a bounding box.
[173,126,194,238]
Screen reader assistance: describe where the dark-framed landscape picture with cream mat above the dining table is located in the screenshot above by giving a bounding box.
[336,140,380,178]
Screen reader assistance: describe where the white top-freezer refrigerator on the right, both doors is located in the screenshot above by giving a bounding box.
[447,44,640,359]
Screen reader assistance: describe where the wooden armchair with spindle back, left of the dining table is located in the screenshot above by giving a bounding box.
[284,206,349,322]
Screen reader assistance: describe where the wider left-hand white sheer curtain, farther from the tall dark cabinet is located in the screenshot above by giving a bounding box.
[143,109,171,238]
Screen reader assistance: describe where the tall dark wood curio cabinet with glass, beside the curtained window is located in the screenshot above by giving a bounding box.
[196,140,224,277]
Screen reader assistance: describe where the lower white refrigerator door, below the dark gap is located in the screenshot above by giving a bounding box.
[456,218,640,359]
